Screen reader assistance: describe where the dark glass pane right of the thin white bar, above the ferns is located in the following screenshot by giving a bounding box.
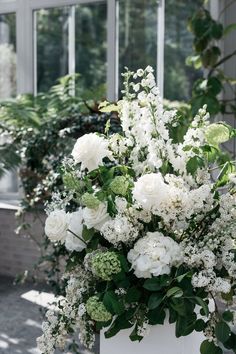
[75,3,107,92]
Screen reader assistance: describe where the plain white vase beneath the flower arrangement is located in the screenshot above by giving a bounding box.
[100,323,204,354]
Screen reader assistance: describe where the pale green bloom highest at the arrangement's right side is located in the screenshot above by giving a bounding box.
[205,123,230,146]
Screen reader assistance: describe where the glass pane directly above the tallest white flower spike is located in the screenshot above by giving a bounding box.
[119,0,157,94]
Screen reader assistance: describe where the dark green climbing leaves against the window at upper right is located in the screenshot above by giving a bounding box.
[187,7,236,115]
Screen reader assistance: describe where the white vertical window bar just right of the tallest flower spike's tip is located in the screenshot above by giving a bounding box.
[156,0,165,97]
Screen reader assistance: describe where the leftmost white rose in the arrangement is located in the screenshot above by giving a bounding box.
[45,210,68,242]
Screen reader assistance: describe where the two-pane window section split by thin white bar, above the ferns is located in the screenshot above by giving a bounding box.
[35,2,107,92]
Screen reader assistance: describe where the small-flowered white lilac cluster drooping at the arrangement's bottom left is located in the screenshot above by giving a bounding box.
[37,269,95,354]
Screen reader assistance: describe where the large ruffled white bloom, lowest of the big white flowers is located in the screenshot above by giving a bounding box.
[127,232,182,278]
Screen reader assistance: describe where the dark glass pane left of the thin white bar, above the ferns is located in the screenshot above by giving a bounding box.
[36,7,69,92]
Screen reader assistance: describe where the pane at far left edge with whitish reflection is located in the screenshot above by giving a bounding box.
[0,13,16,99]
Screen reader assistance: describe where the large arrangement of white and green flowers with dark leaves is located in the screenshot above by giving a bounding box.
[38,66,236,354]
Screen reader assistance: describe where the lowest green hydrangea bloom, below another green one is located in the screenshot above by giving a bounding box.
[86,295,112,322]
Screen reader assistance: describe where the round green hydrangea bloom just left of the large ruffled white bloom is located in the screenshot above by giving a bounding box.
[92,251,121,281]
